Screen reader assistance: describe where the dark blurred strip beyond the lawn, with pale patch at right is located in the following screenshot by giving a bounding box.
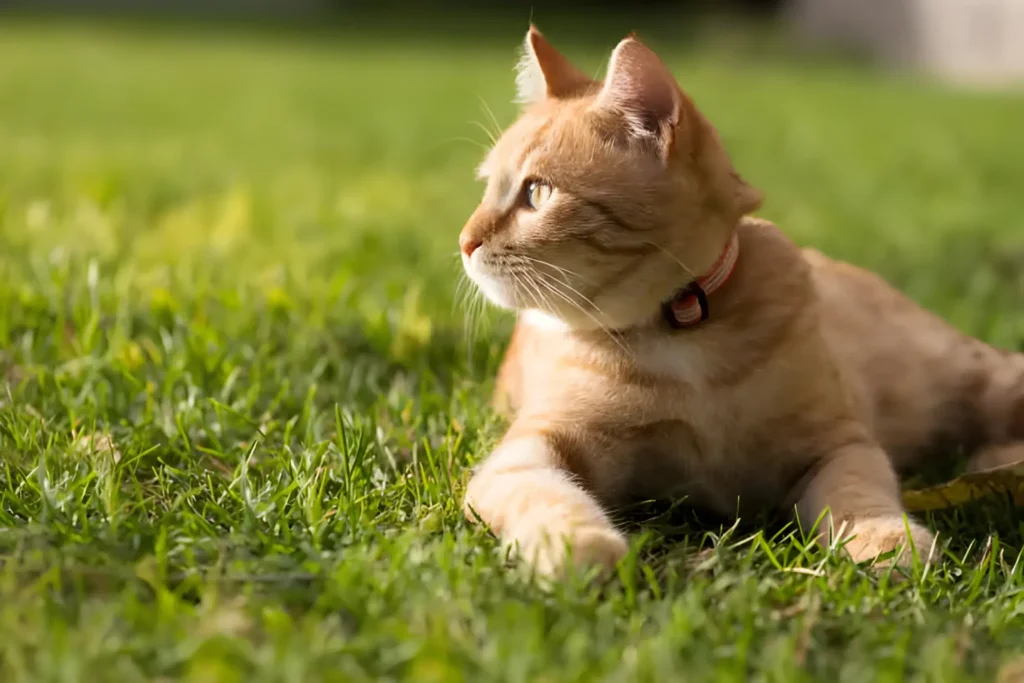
[4,0,1024,82]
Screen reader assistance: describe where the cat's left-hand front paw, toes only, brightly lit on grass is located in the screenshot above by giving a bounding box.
[507,524,629,579]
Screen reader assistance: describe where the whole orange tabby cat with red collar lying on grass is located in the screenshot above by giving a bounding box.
[460,28,1024,575]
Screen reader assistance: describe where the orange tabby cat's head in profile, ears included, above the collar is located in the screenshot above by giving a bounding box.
[459,27,761,329]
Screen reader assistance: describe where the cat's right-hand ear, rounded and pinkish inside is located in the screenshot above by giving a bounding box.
[596,36,683,152]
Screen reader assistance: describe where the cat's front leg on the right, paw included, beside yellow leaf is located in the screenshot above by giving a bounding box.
[796,442,933,564]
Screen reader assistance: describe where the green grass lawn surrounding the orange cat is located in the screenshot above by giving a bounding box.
[0,15,1024,683]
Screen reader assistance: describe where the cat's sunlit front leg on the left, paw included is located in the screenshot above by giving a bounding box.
[464,428,628,577]
